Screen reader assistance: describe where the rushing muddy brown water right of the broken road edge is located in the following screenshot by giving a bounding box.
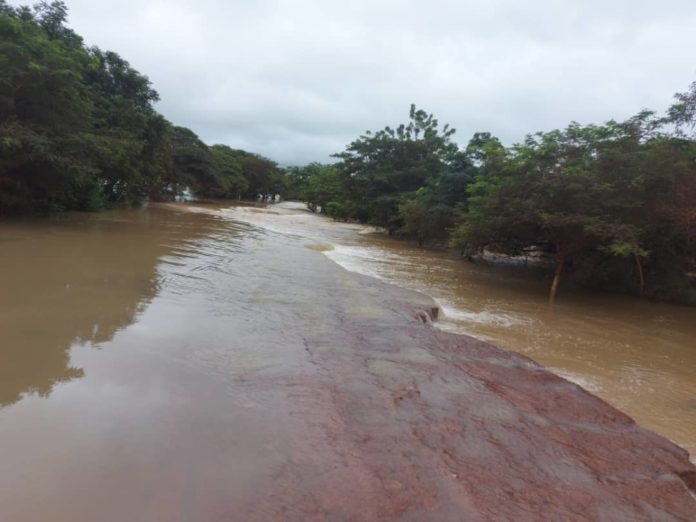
[228,203,696,462]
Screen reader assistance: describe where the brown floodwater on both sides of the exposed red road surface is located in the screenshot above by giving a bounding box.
[0,201,696,522]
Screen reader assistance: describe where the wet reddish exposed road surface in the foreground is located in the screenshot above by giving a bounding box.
[234,284,696,521]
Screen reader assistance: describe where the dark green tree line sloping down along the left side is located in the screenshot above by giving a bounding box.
[0,0,282,215]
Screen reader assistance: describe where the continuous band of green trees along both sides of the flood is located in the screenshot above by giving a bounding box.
[0,0,696,302]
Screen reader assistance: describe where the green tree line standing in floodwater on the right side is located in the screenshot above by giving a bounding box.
[285,96,696,303]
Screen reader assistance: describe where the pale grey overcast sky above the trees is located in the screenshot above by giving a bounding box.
[13,0,696,165]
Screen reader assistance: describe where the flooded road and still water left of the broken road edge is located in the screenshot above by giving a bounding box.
[0,202,696,522]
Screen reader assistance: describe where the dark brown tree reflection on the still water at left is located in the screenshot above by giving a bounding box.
[0,208,228,407]
